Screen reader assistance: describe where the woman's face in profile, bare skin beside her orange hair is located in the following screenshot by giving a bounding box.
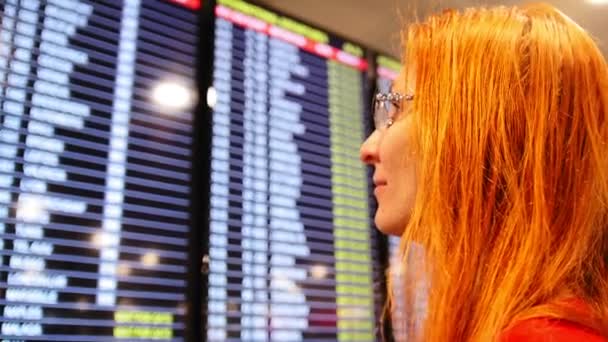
[360,72,416,235]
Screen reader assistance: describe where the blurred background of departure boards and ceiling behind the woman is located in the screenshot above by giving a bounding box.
[0,0,608,342]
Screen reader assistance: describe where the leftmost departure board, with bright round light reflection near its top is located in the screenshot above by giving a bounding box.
[0,0,200,342]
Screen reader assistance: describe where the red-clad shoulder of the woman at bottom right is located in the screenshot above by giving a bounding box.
[499,318,608,342]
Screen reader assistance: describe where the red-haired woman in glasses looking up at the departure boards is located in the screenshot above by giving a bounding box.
[361,5,608,342]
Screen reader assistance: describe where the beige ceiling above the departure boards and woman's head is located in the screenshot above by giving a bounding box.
[255,0,608,57]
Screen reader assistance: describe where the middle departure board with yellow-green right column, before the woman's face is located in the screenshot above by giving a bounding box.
[206,0,376,341]
